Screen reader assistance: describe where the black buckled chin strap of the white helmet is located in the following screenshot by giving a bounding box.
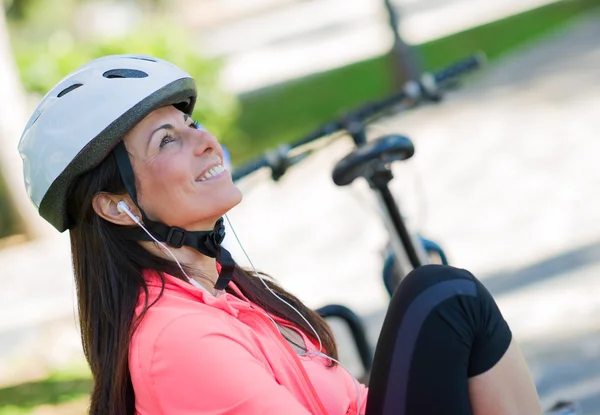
[113,141,235,290]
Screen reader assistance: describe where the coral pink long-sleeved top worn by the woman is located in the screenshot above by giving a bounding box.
[129,272,367,415]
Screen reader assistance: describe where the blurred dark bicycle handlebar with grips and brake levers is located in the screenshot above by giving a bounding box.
[232,53,485,181]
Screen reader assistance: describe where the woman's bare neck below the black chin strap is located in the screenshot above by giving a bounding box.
[140,241,219,295]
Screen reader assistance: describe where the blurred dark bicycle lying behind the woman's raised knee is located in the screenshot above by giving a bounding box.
[232,53,580,415]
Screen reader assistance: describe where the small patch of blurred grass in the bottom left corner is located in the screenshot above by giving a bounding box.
[0,367,92,415]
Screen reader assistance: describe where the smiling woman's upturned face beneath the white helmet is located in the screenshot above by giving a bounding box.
[124,106,242,231]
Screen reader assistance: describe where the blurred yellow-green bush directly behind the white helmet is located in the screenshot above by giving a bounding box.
[13,18,238,143]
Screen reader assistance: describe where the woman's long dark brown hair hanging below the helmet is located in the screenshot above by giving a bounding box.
[68,151,337,415]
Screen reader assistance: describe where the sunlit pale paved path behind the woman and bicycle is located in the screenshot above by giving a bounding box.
[0,10,600,414]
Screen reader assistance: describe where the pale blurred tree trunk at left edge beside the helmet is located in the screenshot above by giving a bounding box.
[0,11,52,239]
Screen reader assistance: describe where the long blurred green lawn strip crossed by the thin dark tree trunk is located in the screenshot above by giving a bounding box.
[231,0,600,164]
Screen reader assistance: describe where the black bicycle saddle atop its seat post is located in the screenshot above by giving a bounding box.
[332,134,415,186]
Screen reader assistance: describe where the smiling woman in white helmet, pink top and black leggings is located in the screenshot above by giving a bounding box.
[19,55,541,415]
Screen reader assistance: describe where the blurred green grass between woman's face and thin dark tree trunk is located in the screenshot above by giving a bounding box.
[231,58,392,162]
